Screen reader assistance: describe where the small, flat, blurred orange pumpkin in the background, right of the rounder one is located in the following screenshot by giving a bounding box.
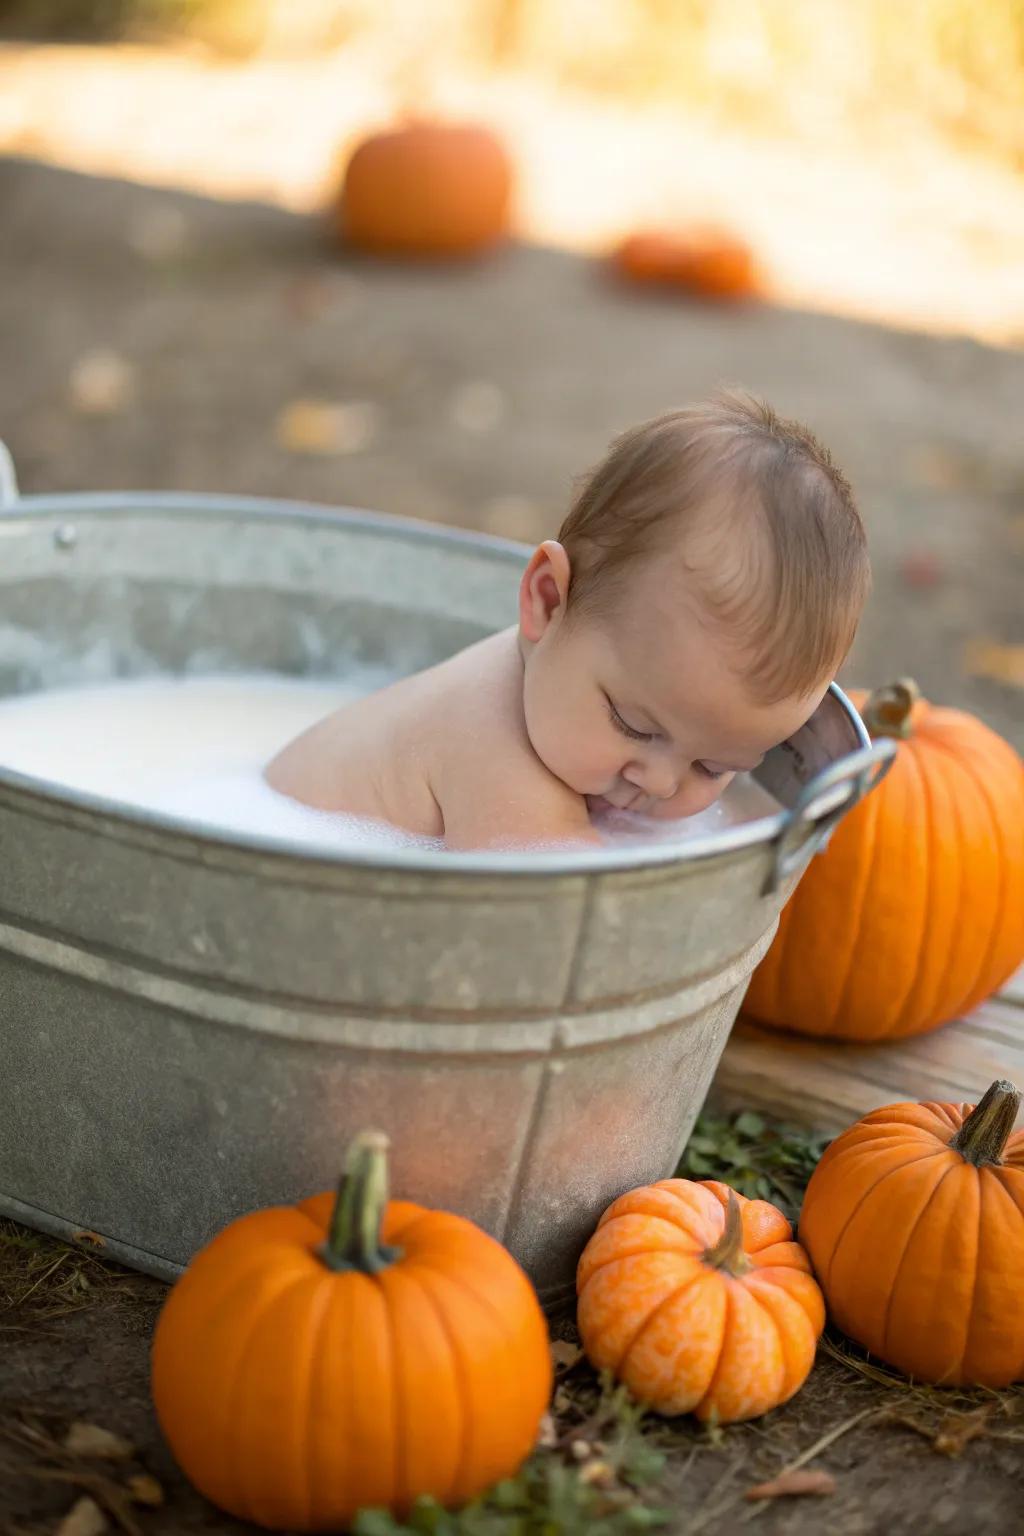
[613,229,758,300]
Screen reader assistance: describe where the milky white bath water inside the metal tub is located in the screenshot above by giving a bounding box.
[0,671,778,849]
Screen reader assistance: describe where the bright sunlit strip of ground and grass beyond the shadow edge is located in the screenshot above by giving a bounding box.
[0,0,1024,341]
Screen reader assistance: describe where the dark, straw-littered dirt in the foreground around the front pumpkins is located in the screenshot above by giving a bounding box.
[0,1240,1024,1536]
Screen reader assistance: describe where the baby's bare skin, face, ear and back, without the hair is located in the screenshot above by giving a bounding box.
[266,541,829,849]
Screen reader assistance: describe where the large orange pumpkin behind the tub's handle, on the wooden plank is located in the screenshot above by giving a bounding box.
[743,682,1024,1040]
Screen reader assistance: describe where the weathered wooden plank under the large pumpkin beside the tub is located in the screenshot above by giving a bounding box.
[709,971,1024,1134]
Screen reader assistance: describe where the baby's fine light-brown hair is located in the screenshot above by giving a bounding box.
[559,390,870,703]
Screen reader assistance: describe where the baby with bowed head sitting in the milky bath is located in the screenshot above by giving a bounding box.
[266,393,869,849]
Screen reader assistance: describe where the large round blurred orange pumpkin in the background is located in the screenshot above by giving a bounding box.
[338,123,511,258]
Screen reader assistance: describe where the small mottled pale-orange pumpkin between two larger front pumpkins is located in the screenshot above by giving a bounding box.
[576,1178,824,1424]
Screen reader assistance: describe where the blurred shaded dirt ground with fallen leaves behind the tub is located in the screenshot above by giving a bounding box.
[0,160,1024,745]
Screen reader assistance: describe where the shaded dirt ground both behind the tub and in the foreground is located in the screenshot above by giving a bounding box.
[0,146,1024,1536]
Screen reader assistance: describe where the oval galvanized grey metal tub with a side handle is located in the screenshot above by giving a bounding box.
[0,451,889,1307]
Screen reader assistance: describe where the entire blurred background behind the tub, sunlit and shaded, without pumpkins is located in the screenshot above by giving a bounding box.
[0,0,1024,746]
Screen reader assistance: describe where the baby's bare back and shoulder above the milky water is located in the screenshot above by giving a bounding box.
[266,630,597,849]
